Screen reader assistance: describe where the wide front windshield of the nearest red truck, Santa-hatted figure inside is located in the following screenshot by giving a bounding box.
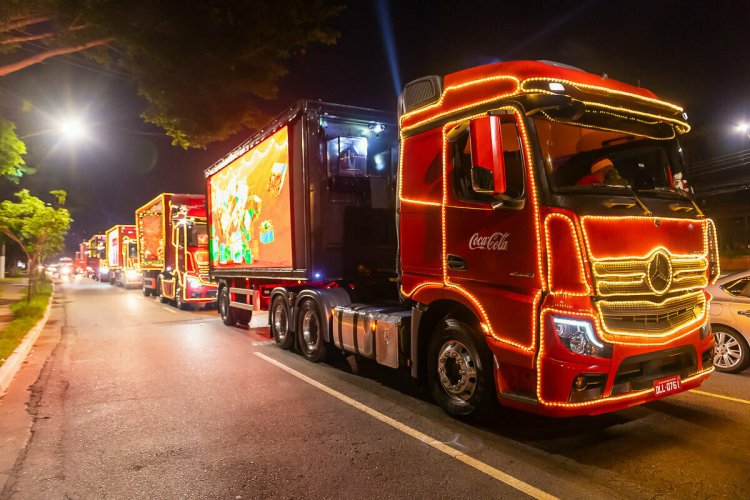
[535,118,689,194]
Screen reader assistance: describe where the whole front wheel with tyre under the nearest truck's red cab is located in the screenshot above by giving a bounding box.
[427,319,495,418]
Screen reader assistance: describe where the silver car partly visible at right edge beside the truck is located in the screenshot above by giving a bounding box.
[706,271,750,373]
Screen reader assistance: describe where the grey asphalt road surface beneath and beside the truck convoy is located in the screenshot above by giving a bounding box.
[0,280,750,499]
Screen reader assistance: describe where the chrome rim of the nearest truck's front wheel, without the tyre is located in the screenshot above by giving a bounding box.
[437,340,477,401]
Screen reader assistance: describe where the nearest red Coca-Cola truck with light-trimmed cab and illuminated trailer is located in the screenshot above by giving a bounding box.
[206,61,719,416]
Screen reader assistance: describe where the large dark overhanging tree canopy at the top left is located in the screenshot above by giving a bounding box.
[0,0,340,147]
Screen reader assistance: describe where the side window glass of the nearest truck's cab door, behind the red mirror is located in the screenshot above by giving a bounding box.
[453,117,524,203]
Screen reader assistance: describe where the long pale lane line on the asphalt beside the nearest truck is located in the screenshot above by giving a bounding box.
[253,352,557,500]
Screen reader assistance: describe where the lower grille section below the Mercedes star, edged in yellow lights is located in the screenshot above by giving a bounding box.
[596,290,706,337]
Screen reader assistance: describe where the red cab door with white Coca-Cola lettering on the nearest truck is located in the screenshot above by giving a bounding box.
[444,112,542,354]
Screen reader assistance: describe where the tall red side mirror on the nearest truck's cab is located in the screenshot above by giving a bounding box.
[469,115,506,194]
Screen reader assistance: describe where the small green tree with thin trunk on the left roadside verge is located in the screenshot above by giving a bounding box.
[0,189,73,300]
